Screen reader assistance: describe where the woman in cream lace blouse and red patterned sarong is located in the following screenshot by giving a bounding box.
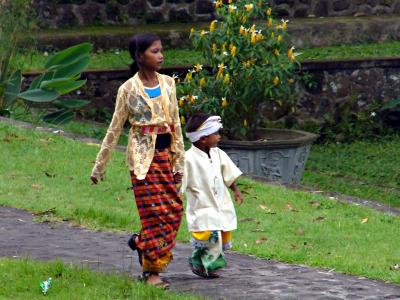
[91,34,184,288]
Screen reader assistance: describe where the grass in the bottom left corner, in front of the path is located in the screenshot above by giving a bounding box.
[0,258,200,300]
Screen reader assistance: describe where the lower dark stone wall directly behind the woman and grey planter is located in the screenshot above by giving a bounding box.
[24,58,400,130]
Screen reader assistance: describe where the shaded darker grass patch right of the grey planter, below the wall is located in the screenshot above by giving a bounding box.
[301,136,400,207]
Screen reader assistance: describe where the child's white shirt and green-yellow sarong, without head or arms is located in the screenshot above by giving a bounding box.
[182,145,242,274]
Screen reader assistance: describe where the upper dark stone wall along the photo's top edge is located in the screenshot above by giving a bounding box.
[34,0,400,28]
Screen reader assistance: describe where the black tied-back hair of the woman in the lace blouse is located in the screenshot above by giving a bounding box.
[129,33,161,75]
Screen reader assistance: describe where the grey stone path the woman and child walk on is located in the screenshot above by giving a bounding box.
[0,207,400,300]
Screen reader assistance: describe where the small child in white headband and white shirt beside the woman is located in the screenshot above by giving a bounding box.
[182,113,243,278]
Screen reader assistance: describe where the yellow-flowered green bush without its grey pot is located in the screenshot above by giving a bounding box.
[178,0,297,139]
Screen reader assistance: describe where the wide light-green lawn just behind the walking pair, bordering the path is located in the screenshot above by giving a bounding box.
[0,123,400,284]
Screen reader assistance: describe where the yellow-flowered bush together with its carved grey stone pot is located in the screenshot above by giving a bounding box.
[178,0,316,183]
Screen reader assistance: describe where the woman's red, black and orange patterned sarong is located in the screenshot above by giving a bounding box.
[131,149,183,273]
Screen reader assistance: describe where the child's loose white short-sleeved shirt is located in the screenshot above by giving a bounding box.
[182,145,242,232]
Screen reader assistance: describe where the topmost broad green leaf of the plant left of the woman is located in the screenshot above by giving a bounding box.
[44,43,92,70]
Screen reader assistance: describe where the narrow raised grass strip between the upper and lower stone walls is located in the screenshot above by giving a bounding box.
[16,41,400,71]
